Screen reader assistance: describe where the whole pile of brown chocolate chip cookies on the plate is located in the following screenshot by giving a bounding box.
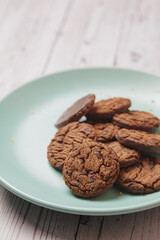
[47,94,160,197]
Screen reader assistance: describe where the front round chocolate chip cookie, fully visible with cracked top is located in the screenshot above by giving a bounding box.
[63,140,119,198]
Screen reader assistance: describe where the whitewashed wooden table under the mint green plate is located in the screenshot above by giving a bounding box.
[0,0,160,240]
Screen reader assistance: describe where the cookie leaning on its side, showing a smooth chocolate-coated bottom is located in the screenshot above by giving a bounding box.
[55,94,95,127]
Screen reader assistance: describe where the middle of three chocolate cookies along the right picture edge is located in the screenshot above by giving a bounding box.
[116,128,160,153]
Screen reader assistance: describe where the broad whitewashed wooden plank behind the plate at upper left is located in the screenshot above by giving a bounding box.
[0,0,73,98]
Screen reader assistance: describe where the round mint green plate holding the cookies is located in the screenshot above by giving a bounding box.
[0,68,160,215]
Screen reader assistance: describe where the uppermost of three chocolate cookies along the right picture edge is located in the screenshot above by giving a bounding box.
[113,111,160,131]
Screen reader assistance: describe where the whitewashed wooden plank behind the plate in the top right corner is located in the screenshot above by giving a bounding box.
[116,0,160,74]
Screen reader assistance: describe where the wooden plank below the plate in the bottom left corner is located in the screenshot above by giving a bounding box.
[0,187,79,240]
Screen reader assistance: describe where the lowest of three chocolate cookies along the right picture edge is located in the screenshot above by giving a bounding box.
[117,156,160,194]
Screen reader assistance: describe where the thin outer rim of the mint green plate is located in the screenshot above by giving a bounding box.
[0,67,160,216]
